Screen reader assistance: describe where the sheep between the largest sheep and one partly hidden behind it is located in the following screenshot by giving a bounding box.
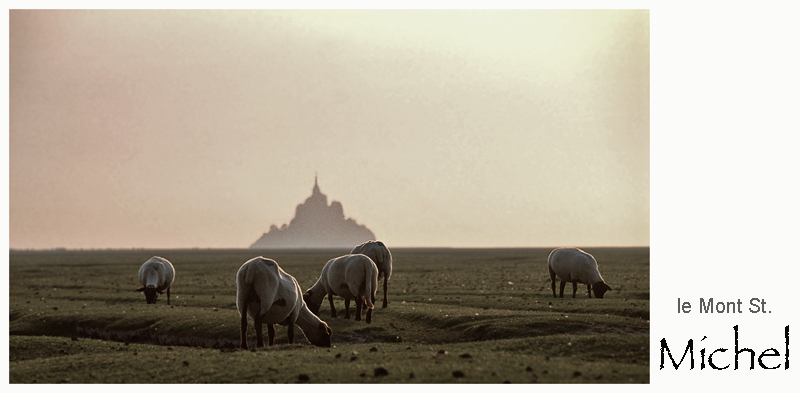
[303,254,378,323]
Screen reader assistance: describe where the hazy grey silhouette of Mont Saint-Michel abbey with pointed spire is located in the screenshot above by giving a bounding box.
[250,176,375,249]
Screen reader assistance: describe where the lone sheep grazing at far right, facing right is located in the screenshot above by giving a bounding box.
[547,247,611,299]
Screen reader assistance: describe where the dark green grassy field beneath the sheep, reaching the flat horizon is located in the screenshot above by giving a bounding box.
[9,248,650,383]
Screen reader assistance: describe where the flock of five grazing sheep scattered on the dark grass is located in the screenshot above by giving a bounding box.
[137,240,611,349]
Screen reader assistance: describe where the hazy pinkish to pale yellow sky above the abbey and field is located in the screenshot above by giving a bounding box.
[9,10,650,248]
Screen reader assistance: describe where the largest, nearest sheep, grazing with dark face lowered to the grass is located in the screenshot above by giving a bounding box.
[236,257,333,349]
